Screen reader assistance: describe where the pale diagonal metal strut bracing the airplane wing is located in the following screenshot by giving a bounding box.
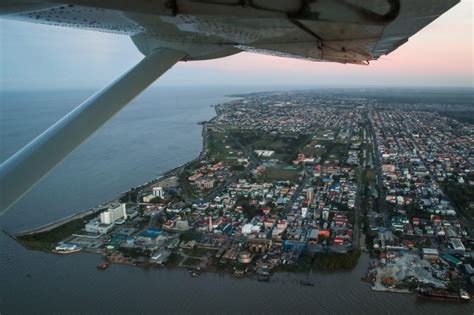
[0,49,185,214]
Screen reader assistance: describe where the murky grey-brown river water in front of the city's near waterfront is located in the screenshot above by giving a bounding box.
[0,241,472,314]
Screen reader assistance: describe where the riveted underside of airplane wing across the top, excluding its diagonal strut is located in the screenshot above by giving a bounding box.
[0,0,459,64]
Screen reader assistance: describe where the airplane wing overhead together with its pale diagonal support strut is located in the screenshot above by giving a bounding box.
[0,0,458,214]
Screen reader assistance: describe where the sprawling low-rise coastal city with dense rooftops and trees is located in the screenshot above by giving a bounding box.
[16,90,474,300]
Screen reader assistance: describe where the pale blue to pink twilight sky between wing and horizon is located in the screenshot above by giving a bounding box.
[0,0,474,90]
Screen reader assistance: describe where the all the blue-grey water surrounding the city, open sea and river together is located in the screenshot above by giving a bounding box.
[0,87,474,315]
